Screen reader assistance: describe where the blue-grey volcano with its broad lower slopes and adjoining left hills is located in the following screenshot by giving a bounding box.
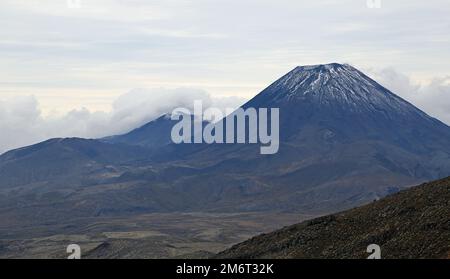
[0,64,450,225]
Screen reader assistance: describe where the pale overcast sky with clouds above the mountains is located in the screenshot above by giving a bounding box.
[0,0,450,152]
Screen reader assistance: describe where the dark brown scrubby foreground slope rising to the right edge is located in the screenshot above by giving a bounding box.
[217,177,450,258]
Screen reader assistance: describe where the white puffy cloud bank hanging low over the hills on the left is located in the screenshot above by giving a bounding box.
[0,88,245,153]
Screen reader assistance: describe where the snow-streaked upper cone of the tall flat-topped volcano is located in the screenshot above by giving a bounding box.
[247,63,429,121]
